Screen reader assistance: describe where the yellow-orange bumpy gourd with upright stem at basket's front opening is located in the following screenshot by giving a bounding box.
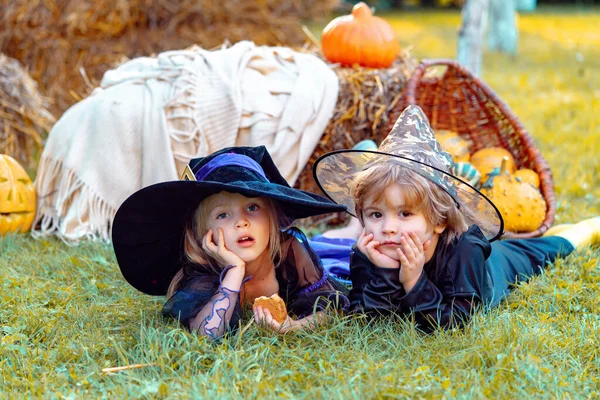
[481,157,546,232]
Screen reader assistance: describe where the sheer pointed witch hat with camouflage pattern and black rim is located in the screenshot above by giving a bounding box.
[313,106,504,241]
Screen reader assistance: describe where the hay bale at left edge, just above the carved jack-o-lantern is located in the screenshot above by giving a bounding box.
[0,53,55,167]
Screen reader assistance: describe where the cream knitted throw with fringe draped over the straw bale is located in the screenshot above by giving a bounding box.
[32,42,339,244]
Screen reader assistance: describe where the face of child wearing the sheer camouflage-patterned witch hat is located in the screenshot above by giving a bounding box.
[362,184,445,261]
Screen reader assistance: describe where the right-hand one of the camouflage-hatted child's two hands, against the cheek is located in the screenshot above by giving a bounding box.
[396,232,431,293]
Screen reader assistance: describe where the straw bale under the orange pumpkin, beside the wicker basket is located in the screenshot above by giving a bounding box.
[295,49,417,226]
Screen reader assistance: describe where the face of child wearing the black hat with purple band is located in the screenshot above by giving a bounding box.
[204,192,271,263]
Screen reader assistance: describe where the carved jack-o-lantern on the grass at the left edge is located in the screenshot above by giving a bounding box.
[0,154,36,235]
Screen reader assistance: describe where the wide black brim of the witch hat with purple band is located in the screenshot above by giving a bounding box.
[112,146,346,295]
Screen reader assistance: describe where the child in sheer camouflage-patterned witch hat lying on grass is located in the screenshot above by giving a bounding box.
[314,106,600,332]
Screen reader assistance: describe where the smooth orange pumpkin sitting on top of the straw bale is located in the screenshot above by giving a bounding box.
[321,2,400,68]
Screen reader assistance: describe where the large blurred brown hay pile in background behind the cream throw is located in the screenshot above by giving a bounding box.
[0,0,339,115]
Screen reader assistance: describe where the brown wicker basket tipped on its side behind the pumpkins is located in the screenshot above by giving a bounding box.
[389,60,556,238]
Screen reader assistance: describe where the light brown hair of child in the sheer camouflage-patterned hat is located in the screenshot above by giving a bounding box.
[351,162,468,243]
